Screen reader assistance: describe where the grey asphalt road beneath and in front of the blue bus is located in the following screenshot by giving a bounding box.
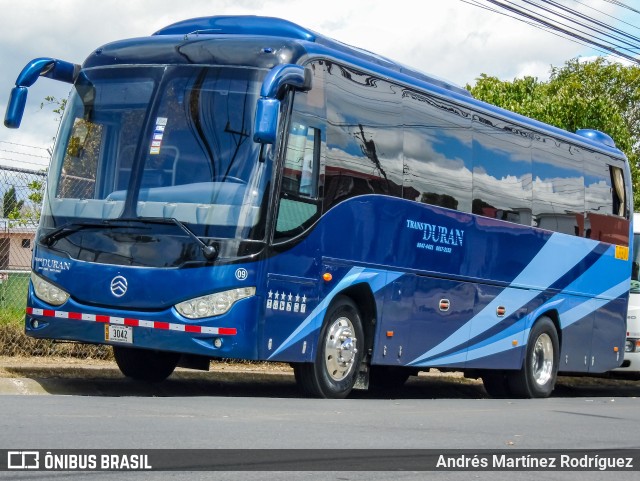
[0,363,640,480]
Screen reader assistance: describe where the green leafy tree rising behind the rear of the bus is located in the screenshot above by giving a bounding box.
[467,58,640,210]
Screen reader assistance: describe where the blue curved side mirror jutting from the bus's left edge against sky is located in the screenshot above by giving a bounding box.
[4,57,80,129]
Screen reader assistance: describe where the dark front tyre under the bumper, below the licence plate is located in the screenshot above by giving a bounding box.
[113,346,180,382]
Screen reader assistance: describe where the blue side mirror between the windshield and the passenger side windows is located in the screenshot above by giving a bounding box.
[253,64,311,144]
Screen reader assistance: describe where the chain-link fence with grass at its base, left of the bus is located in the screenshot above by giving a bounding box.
[0,141,111,359]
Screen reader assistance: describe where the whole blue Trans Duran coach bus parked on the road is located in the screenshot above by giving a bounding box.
[5,16,632,398]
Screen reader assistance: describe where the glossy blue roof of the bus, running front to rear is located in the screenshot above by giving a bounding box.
[83,15,624,158]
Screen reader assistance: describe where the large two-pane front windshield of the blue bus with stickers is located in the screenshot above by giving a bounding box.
[42,66,270,244]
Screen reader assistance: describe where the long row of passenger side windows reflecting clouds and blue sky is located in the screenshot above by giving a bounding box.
[302,61,629,240]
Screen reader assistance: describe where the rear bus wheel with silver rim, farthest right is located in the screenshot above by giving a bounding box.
[509,317,559,398]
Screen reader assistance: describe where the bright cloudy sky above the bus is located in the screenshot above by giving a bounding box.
[0,0,632,168]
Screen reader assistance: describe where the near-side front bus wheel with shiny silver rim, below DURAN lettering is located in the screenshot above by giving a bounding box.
[294,296,364,399]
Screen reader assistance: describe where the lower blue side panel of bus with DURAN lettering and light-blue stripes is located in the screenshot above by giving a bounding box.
[258,196,630,371]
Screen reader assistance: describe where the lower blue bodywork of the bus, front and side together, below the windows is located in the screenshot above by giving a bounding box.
[27,196,630,372]
